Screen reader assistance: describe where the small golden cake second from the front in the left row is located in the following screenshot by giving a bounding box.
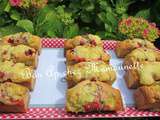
[0,61,35,90]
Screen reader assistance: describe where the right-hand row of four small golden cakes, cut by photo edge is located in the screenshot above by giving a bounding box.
[115,39,160,111]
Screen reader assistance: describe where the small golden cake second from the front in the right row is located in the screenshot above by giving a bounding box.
[124,62,160,89]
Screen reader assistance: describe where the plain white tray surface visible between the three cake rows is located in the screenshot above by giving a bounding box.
[30,48,134,107]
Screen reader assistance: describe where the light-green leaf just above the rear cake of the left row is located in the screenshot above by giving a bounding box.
[16,19,34,33]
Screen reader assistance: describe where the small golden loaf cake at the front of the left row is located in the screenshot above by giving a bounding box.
[0,82,30,113]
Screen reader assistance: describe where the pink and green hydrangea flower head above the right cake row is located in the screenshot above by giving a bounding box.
[118,17,159,42]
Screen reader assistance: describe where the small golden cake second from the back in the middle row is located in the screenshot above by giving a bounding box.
[66,46,110,64]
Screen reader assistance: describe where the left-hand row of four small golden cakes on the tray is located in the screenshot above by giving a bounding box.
[0,32,41,112]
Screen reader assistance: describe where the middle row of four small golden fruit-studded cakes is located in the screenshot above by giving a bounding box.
[64,34,123,113]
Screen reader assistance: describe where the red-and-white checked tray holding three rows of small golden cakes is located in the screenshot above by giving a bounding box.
[0,33,160,119]
